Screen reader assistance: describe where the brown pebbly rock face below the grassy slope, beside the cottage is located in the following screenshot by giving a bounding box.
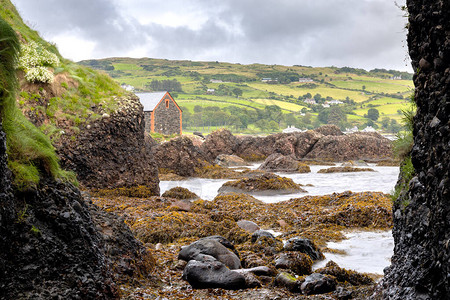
[56,96,159,195]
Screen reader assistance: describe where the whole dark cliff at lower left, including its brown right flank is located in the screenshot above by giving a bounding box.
[0,124,154,300]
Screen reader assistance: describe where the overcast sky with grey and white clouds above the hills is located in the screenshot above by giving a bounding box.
[12,0,412,71]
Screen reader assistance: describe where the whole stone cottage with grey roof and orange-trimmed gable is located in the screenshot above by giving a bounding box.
[136,92,183,135]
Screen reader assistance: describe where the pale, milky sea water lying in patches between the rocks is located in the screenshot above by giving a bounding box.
[159,163,399,276]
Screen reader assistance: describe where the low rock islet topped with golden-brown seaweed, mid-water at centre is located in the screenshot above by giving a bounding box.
[219,173,306,195]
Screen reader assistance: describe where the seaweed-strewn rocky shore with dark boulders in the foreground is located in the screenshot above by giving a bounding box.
[92,192,392,299]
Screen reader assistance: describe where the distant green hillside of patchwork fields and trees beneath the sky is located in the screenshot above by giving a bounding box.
[79,58,413,133]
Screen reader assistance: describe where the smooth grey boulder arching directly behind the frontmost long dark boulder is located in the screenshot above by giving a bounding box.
[178,239,241,269]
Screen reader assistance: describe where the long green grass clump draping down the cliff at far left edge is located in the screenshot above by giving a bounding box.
[0,18,75,189]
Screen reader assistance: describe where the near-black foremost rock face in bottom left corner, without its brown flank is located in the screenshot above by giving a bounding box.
[0,179,118,299]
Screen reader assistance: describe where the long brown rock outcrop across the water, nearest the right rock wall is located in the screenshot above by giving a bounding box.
[305,133,392,161]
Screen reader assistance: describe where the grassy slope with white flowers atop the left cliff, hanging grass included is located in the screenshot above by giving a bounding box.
[0,0,125,189]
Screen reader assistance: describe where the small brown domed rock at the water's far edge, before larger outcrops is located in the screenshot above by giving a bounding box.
[258,153,311,173]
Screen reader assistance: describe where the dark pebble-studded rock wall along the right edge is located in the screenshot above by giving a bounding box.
[384,0,450,299]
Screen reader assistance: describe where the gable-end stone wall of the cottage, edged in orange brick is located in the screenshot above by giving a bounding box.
[153,95,181,135]
